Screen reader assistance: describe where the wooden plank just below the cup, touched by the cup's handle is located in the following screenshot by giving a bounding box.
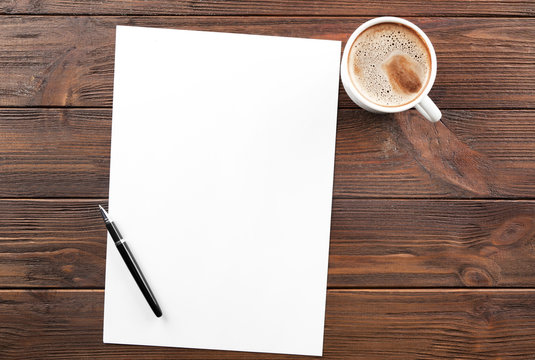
[4,109,535,198]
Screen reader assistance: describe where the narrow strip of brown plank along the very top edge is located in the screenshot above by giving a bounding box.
[0,0,535,16]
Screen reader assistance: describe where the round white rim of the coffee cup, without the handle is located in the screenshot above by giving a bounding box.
[341,16,437,113]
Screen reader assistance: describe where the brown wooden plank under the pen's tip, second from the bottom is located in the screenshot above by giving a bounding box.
[0,199,535,288]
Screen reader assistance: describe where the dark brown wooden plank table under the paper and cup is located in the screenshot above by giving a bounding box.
[0,0,535,360]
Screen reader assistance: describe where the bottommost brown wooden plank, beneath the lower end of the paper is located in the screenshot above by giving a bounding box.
[0,290,535,360]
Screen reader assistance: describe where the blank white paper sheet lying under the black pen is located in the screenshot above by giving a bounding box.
[104,26,341,355]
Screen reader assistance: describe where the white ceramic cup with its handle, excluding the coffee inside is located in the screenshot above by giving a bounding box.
[340,16,442,122]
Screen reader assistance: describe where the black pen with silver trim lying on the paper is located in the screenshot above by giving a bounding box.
[98,205,162,317]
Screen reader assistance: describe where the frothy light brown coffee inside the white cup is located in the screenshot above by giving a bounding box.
[348,23,431,107]
